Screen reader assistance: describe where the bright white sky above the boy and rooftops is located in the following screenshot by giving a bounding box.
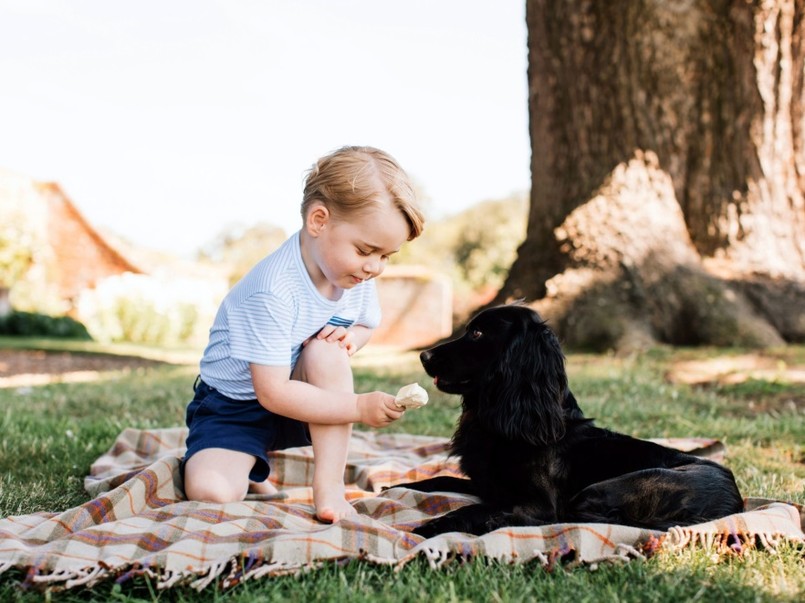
[0,0,530,257]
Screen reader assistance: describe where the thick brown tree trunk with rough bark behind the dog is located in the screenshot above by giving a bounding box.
[496,0,805,349]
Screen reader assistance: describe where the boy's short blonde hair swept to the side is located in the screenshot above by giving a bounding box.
[302,146,425,241]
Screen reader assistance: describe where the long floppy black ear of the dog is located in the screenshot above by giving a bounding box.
[478,317,567,446]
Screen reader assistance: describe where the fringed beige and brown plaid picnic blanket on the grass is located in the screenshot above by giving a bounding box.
[0,428,805,590]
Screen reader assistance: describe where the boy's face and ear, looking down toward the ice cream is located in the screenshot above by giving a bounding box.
[303,199,410,296]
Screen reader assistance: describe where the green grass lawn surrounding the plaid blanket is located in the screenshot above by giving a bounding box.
[0,341,805,602]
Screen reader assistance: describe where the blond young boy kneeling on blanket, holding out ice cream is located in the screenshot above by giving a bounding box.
[183,147,424,522]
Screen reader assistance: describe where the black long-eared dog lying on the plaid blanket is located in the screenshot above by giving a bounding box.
[402,305,743,537]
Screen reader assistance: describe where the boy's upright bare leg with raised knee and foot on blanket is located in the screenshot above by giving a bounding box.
[292,339,357,522]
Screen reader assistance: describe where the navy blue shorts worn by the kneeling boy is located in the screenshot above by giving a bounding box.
[182,378,310,482]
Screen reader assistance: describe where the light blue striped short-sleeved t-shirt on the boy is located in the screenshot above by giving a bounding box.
[201,232,380,400]
